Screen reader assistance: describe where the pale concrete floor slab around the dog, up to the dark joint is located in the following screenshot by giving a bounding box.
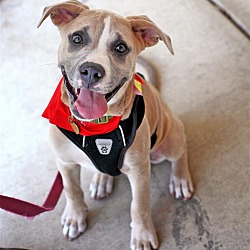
[0,0,250,250]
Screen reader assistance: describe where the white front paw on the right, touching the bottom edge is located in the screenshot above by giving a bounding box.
[130,223,159,250]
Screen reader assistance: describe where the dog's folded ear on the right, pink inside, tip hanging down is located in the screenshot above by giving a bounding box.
[127,15,174,55]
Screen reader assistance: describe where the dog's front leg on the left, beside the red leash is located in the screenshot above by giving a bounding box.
[57,159,87,239]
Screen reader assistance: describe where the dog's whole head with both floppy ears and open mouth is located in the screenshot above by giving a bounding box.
[38,1,173,120]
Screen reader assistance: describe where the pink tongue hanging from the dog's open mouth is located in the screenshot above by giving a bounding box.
[75,89,108,119]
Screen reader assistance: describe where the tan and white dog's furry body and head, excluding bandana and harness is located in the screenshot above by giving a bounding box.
[38,1,193,250]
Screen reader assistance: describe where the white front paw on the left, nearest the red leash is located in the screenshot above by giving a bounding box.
[61,201,87,240]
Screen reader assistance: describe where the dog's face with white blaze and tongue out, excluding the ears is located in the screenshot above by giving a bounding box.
[58,11,138,119]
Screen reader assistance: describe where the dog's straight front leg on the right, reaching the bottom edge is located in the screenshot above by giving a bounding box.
[127,157,158,250]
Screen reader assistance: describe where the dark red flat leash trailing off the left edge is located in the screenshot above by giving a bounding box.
[0,172,63,219]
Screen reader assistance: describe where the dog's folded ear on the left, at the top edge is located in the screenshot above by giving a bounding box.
[37,0,89,28]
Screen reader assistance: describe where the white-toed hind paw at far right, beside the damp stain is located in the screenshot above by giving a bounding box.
[169,173,194,200]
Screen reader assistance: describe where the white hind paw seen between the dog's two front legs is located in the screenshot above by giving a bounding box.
[89,173,114,199]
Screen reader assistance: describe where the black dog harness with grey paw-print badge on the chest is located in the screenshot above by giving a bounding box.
[58,95,156,176]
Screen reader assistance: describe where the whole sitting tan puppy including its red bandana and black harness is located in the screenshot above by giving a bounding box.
[38,1,193,250]
